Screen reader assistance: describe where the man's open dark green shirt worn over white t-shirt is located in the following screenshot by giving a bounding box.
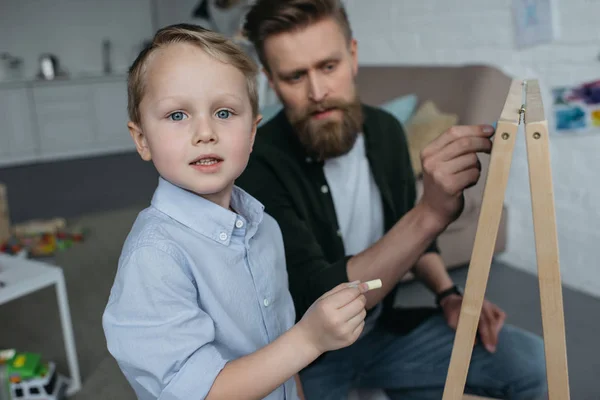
[236,105,437,332]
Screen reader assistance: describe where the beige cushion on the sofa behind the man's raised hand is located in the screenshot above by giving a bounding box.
[406,101,458,177]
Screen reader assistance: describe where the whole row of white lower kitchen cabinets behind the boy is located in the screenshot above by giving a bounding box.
[0,76,135,167]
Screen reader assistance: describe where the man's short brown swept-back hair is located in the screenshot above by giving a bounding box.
[243,0,352,70]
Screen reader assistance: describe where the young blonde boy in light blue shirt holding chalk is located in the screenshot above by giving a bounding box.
[103,25,376,400]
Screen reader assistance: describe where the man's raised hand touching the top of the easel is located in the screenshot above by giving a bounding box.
[421,125,494,231]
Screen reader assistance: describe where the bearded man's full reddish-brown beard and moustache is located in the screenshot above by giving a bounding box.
[288,96,363,161]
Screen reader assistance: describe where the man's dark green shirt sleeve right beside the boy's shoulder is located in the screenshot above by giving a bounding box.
[238,157,350,320]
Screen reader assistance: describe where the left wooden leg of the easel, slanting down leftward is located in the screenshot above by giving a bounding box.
[443,80,522,400]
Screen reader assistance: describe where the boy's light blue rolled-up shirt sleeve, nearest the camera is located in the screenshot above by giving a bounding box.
[103,246,228,400]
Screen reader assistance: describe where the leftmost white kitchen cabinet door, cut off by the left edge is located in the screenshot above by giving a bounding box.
[0,87,38,166]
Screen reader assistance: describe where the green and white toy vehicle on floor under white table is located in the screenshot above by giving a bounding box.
[0,350,68,400]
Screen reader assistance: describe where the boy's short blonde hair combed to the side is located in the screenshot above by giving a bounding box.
[127,24,258,124]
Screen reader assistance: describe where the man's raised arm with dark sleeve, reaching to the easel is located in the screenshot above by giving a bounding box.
[237,126,493,317]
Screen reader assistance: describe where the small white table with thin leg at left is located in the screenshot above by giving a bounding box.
[0,254,81,396]
